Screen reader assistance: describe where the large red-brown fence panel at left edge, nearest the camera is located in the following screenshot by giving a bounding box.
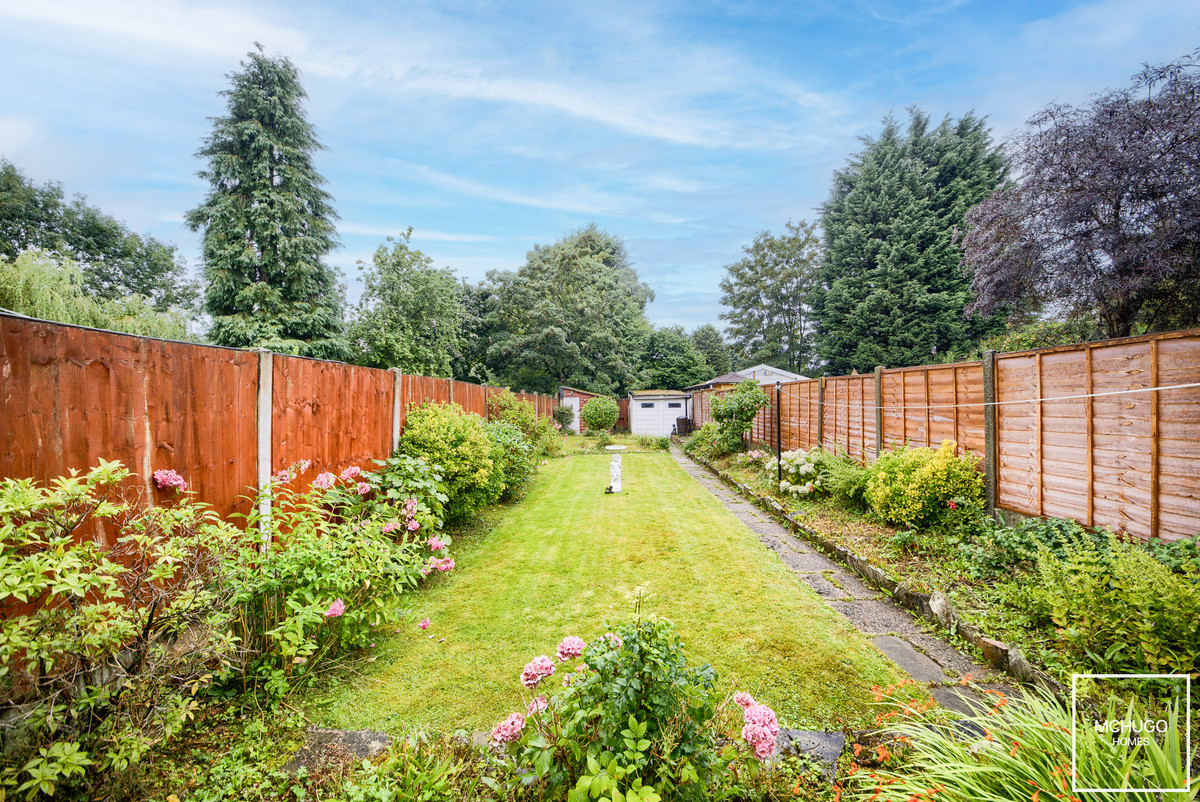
[0,316,258,525]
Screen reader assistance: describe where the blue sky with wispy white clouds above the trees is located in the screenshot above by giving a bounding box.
[0,0,1200,329]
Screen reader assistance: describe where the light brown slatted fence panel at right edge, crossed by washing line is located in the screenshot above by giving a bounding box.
[996,330,1200,540]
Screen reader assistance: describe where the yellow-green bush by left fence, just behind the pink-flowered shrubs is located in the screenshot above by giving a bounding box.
[400,402,499,521]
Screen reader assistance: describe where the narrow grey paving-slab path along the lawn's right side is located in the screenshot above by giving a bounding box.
[671,444,997,713]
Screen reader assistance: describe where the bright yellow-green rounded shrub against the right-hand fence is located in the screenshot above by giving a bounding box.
[866,439,983,531]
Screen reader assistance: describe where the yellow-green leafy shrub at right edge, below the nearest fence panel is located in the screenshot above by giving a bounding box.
[1038,535,1200,674]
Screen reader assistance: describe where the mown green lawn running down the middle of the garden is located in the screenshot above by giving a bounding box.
[308,453,902,732]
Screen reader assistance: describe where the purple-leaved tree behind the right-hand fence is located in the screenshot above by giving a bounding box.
[962,50,1200,337]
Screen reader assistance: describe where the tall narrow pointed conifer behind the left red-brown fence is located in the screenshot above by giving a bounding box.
[187,46,348,359]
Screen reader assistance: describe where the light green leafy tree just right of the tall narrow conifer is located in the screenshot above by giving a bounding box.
[349,228,463,376]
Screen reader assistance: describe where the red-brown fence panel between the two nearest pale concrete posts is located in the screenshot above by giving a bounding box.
[271,354,395,481]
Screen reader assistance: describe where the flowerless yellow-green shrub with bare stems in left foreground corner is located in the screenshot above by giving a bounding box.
[0,461,244,798]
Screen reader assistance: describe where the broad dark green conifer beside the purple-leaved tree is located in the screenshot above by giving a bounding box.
[809,109,1007,373]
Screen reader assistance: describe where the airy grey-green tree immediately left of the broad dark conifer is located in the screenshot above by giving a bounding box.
[714,220,821,376]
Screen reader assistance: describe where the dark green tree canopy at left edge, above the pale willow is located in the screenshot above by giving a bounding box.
[0,160,198,312]
